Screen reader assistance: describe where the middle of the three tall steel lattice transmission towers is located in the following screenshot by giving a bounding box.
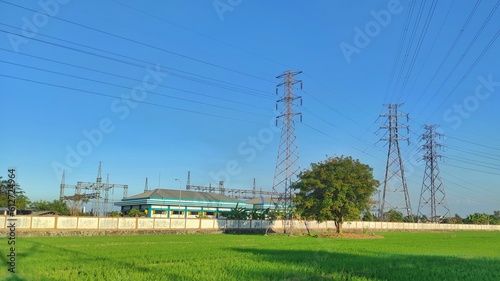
[379,104,412,220]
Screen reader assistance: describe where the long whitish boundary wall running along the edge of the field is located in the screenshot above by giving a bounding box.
[0,216,500,231]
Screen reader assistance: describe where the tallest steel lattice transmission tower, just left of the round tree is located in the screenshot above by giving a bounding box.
[273,70,302,228]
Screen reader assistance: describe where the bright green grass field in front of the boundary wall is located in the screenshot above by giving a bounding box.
[0,232,500,281]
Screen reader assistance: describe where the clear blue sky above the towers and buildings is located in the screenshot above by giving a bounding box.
[0,0,500,215]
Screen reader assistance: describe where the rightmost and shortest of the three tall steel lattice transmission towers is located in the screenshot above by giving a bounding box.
[417,125,450,222]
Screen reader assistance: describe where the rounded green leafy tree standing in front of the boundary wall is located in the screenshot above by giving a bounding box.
[292,156,379,233]
